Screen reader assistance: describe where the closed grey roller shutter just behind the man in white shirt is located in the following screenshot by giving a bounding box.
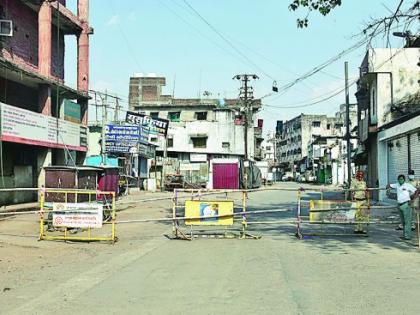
[388,136,408,183]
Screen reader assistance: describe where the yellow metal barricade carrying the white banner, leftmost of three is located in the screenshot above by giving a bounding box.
[39,188,117,243]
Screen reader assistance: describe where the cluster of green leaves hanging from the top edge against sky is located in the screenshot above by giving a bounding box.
[289,0,342,28]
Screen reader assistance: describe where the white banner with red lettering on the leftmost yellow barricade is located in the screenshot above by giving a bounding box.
[53,203,103,228]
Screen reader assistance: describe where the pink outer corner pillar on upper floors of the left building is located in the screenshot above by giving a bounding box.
[77,0,90,92]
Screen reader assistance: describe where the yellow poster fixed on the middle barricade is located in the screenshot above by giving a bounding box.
[185,200,233,225]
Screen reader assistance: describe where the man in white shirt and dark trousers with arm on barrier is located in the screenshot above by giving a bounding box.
[387,175,419,240]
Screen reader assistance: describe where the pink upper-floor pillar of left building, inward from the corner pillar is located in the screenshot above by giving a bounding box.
[38,1,52,77]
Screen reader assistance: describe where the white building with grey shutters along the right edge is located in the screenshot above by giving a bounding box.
[355,47,420,199]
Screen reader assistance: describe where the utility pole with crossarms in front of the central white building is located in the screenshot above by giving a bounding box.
[233,74,259,189]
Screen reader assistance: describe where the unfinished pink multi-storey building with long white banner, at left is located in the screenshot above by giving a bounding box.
[0,0,92,204]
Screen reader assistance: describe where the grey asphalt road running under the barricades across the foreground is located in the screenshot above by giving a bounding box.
[0,184,420,314]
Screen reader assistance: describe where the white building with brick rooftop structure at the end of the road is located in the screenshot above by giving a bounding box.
[129,76,261,187]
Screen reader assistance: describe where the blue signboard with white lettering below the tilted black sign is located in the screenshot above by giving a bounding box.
[105,125,140,153]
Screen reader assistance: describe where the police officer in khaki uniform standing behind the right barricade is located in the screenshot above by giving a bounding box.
[350,171,368,234]
